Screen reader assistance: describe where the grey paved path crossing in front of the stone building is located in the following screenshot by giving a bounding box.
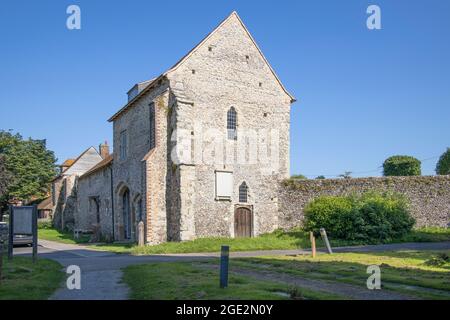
[14,240,450,300]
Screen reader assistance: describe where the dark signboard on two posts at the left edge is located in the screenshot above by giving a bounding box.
[8,205,37,262]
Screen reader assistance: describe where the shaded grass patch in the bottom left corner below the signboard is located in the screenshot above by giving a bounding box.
[0,256,64,300]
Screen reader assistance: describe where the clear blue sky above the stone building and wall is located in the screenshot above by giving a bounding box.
[0,0,450,177]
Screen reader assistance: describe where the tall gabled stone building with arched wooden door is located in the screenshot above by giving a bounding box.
[109,12,295,244]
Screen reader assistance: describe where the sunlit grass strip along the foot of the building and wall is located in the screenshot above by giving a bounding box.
[39,228,450,254]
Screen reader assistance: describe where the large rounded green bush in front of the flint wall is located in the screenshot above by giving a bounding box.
[304,192,415,243]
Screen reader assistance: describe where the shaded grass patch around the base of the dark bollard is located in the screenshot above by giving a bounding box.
[123,262,339,300]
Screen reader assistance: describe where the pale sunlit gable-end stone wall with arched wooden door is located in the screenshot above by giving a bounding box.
[168,15,292,240]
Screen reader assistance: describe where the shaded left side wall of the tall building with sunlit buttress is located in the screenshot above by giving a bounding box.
[113,81,168,243]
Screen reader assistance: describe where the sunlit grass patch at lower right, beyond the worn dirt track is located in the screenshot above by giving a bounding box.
[231,250,450,299]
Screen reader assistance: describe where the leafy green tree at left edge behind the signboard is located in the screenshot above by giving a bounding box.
[0,131,56,208]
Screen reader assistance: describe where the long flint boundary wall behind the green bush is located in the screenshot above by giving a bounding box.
[278,175,450,229]
